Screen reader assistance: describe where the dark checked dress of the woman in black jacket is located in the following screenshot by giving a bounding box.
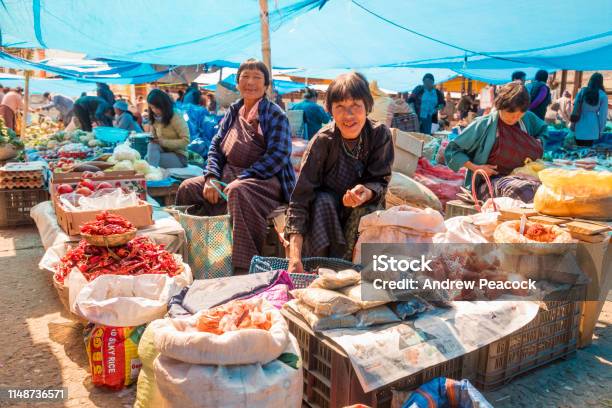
[302,148,380,259]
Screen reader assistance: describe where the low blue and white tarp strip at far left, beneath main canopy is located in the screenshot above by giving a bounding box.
[0,51,168,84]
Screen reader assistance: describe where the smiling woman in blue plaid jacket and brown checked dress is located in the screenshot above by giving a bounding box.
[176,60,295,274]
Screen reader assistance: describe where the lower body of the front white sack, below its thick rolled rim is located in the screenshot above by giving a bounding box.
[154,335,304,408]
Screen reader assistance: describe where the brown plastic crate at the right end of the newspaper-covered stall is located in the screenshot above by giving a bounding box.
[475,286,586,391]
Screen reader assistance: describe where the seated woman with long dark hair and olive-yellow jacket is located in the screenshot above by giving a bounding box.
[146,89,189,169]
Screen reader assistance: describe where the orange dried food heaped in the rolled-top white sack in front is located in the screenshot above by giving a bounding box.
[197,299,272,334]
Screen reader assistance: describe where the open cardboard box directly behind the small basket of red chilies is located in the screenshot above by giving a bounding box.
[54,201,154,235]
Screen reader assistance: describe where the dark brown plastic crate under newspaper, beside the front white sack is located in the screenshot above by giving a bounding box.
[282,310,477,408]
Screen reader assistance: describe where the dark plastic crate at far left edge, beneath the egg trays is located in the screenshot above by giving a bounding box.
[0,188,49,227]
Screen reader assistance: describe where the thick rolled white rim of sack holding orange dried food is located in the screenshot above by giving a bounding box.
[155,302,289,365]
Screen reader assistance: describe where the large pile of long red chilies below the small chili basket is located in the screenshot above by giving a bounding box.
[55,237,180,282]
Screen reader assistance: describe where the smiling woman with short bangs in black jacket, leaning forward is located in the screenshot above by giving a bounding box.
[285,72,393,272]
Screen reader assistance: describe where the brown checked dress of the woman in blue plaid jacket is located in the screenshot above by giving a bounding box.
[176,116,282,272]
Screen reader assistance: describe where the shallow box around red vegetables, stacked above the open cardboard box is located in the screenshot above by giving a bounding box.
[49,170,147,205]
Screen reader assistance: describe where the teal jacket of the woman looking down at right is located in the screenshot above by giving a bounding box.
[444,111,548,187]
